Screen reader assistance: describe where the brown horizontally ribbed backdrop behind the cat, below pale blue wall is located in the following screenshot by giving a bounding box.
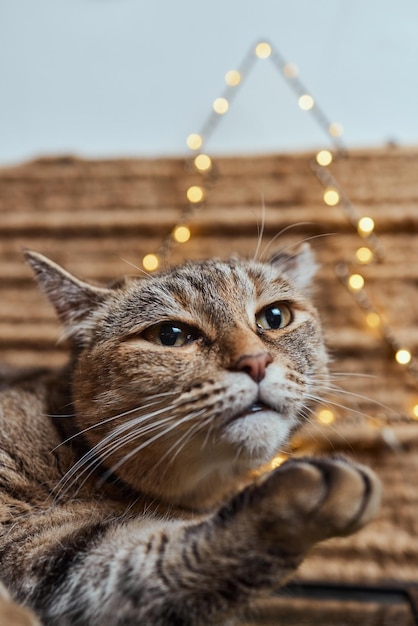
[0,148,418,580]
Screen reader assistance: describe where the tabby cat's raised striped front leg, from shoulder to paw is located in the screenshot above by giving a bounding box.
[22,459,380,626]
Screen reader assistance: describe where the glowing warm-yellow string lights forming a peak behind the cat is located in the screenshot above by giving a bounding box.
[143,41,418,420]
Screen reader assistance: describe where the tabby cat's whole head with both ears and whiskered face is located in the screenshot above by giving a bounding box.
[26,245,326,504]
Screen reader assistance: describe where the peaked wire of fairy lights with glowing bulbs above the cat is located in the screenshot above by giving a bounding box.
[142,41,418,424]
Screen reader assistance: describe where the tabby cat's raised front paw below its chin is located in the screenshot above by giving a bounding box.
[251,459,381,554]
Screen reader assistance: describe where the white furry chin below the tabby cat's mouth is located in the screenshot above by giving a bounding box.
[222,404,297,468]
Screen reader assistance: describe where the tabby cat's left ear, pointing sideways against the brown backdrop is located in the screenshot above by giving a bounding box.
[24,250,111,335]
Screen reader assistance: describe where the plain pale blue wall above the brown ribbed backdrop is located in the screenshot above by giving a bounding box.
[0,0,418,165]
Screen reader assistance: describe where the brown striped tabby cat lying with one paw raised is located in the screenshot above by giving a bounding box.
[0,244,380,626]
